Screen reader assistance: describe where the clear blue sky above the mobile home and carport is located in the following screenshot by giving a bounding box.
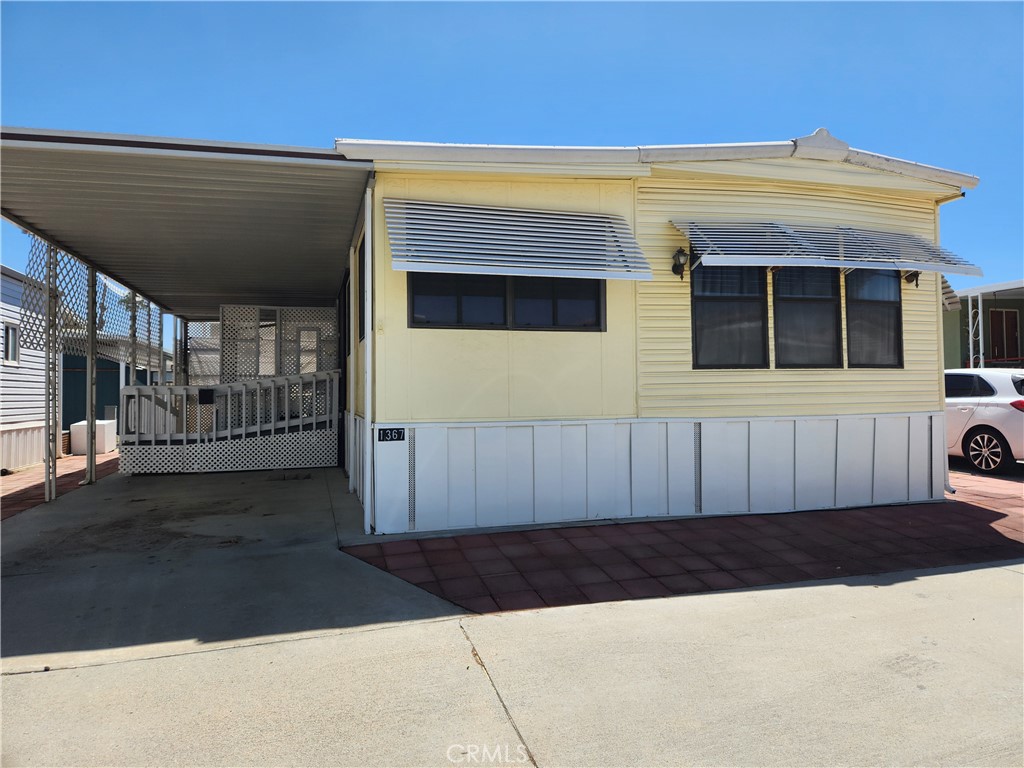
[0,2,1024,288]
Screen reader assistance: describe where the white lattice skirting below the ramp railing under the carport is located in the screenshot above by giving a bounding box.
[120,429,338,475]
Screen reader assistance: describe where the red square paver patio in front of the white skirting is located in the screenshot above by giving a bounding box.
[344,466,1024,613]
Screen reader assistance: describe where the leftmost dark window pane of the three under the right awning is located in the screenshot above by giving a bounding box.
[691,264,768,368]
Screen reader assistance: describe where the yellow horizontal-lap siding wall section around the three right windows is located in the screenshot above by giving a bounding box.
[636,168,942,417]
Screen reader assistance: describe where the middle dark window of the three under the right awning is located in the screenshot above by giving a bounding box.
[773,266,843,368]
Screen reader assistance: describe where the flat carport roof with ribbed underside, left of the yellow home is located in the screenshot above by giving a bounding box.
[0,128,372,319]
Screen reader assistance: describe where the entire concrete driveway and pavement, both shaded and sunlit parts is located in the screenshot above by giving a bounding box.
[0,471,1024,766]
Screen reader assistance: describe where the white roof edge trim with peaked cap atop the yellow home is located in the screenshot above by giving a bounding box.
[335,128,978,189]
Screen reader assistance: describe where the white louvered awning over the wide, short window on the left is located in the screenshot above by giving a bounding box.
[384,199,651,280]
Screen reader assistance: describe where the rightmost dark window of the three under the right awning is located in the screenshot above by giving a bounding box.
[846,269,903,368]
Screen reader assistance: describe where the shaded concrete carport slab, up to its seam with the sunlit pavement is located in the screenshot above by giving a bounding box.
[2,470,463,672]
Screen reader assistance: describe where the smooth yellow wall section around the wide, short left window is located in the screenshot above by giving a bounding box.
[374,172,636,422]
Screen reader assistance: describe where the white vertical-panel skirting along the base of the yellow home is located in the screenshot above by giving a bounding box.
[370,413,945,534]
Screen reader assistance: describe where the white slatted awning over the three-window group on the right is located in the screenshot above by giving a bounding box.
[672,219,981,275]
